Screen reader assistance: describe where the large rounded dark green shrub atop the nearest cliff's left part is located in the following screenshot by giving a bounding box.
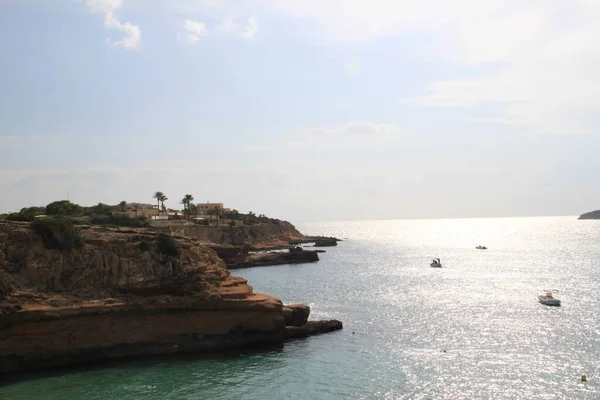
[31,217,83,251]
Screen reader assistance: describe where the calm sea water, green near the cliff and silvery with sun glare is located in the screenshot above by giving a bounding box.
[0,217,600,400]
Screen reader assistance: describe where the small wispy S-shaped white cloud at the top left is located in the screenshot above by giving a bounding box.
[86,0,142,50]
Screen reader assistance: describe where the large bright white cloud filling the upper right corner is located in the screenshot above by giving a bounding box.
[247,0,600,133]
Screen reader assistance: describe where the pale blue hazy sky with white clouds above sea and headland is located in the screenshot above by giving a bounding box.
[0,0,600,221]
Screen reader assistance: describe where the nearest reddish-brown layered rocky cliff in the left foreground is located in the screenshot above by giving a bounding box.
[0,222,341,374]
